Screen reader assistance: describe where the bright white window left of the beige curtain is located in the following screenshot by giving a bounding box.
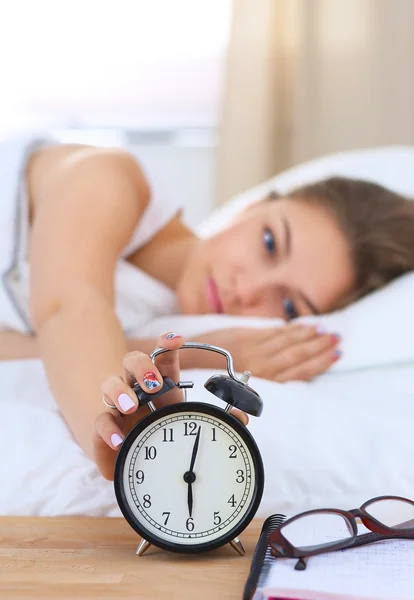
[0,0,231,130]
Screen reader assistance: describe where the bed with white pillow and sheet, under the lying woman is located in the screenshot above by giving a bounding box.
[0,146,414,517]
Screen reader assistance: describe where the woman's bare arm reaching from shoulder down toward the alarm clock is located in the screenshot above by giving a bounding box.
[29,148,149,457]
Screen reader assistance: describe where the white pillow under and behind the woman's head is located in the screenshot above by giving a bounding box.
[186,146,414,371]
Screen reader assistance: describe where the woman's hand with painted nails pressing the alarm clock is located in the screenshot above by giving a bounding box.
[94,333,248,479]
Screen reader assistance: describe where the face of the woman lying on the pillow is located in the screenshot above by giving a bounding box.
[177,198,354,320]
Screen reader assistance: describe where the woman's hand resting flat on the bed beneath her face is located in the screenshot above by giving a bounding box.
[197,323,340,382]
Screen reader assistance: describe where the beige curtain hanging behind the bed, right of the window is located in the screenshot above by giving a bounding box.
[218,0,414,203]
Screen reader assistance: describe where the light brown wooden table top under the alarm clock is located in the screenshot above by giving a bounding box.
[0,517,263,600]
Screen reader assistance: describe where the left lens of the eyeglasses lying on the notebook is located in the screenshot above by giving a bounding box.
[280,511,353,551]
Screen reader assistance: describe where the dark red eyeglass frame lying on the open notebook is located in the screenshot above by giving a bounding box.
[269,496,414,558]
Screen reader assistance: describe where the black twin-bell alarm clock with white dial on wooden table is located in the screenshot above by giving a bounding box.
[114,342,264,556]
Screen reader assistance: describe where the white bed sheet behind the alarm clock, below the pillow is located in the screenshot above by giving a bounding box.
[0,360,414,517]
